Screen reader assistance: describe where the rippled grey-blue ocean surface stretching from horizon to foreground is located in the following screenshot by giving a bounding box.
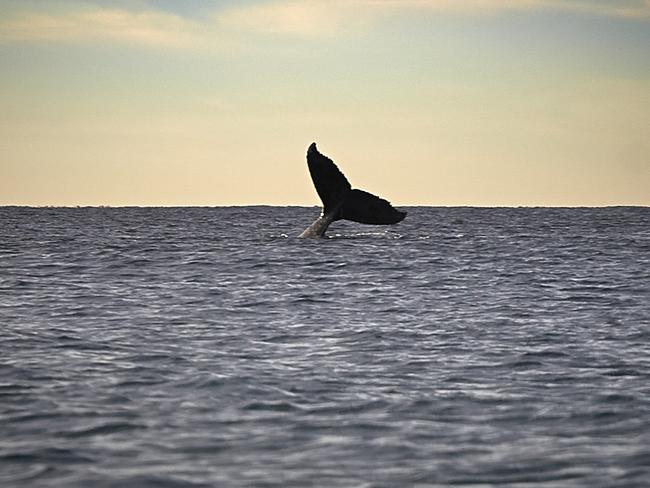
[0,207,650,488]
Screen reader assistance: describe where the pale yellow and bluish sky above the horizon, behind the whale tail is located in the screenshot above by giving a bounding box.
[0,0,650,206]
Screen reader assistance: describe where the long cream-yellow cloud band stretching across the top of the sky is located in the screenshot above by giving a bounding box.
[0,0,650,48]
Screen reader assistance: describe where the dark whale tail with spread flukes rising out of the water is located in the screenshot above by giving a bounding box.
[300,142,406,237]
